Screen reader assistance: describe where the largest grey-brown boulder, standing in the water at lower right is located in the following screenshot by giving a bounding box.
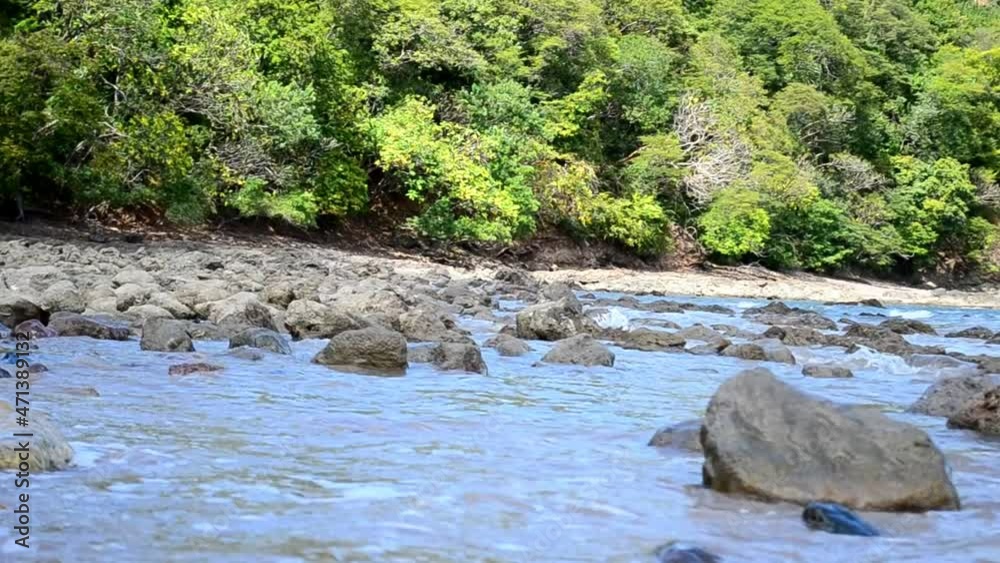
[701,369,960,511]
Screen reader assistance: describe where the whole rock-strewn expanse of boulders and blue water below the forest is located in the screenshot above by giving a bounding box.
[0,232,1000,561]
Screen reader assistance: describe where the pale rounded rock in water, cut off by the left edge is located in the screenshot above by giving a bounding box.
[0,401,73,478]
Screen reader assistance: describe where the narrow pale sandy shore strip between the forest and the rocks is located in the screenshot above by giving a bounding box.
[0,219,1000,309]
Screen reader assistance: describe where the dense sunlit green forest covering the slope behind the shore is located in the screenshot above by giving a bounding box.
[0,0,1000,271]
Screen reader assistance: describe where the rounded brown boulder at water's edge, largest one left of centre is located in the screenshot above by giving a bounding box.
[313,326,407,374]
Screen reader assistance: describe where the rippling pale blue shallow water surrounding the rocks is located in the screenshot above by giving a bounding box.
[0,294,1000,563]
